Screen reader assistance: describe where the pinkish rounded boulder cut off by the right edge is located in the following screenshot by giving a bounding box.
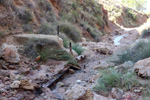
[134,58,150,77]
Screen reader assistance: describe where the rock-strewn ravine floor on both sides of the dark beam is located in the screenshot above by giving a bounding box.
[0,20,145,100]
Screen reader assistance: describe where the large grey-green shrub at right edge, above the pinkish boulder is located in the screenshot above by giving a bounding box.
[117,39,150,64]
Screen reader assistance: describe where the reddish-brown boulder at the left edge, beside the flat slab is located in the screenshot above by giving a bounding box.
[0,43,20,63]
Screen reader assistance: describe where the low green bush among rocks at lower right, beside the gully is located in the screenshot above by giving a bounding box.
[93,68,141,95]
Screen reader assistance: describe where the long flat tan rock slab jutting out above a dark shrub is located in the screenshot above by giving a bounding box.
[14,34,63,48]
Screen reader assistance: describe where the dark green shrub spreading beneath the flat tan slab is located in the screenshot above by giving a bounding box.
[24,39,73,61]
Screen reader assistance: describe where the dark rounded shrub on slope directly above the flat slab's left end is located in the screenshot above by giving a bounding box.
[18,9,33,23]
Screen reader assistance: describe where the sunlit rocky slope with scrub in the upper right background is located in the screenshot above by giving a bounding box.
[97,0,148,27]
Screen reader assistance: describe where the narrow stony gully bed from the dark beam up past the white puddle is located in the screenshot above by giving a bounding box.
[50,23,139,100]
